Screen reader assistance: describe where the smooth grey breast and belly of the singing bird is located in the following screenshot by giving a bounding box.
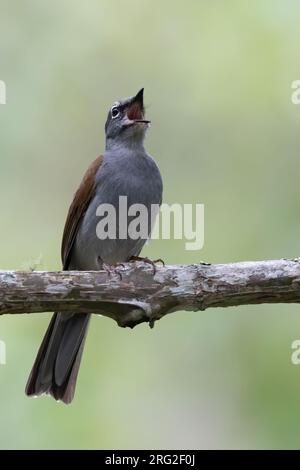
[71,153,162,270]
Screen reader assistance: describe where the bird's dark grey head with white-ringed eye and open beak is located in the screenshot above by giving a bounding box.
[105,88,150,146]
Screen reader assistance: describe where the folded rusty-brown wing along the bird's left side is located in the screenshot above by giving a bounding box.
[61,155,103,269]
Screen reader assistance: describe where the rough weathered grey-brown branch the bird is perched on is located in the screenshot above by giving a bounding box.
[0,259,300,327]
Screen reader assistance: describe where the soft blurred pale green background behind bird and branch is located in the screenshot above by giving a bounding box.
[0,0,300,449]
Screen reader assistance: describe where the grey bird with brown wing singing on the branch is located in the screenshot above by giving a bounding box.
[25,88,163,404]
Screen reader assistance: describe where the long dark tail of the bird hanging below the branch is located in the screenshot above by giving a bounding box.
[25,313,90,403]
